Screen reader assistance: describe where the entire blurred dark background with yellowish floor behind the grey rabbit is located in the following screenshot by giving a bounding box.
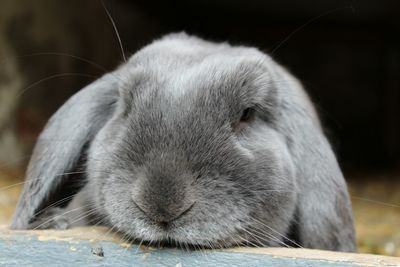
[0,0,400,256]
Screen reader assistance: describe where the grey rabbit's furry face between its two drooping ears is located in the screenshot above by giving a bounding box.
[88,40,296,247]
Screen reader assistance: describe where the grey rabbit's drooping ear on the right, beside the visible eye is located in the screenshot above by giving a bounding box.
[269,64,356,251]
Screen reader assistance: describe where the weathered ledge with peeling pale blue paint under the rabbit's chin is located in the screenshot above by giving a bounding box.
[0,227,400,267]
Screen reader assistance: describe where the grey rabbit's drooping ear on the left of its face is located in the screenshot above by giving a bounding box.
[11,73,118,229]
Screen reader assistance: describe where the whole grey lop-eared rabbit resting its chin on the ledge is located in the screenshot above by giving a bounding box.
[11,33,356,251]
